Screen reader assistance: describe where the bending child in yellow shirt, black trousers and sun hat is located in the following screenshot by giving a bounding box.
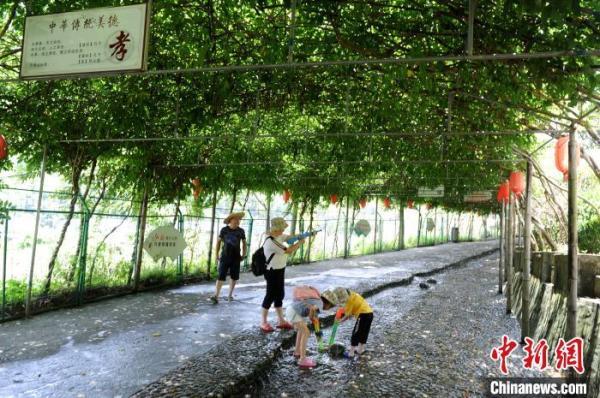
[321,287,373,358]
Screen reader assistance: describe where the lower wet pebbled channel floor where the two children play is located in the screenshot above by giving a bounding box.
[251,255,549,398]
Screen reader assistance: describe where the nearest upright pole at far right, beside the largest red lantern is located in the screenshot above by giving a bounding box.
[566,128,579,340]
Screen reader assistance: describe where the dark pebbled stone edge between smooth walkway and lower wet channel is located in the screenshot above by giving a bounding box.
[131,248,498,398]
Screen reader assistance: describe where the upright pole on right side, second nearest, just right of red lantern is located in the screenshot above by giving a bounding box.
[521,162,533,344]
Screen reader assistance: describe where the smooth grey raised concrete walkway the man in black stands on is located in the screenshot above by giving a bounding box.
[0,242,497,397]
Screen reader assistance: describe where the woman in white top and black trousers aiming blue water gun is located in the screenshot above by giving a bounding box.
[260,217,304,332]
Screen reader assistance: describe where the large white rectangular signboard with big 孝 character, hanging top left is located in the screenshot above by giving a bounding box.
[21,4,149,79]
